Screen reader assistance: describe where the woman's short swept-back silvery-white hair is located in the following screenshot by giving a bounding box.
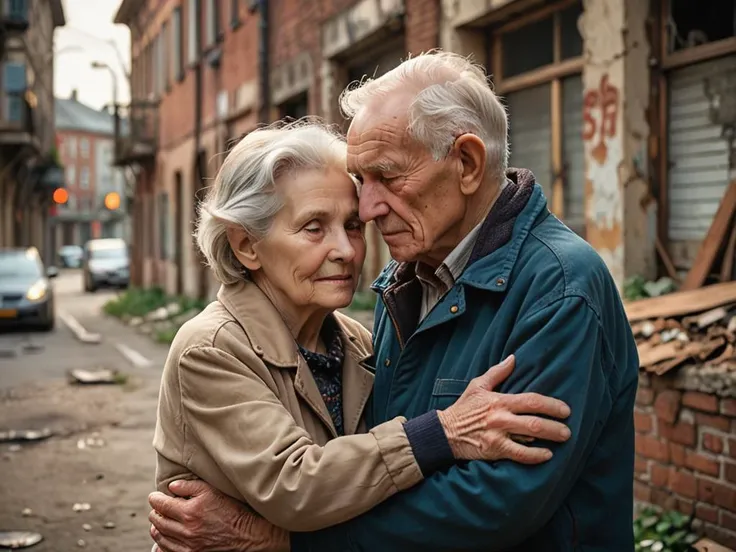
[194,118,347,284]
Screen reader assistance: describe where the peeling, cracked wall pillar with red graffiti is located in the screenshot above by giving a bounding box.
[578,0,656,289]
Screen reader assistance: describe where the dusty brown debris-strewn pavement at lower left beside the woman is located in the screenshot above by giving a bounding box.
[0,317,167,552]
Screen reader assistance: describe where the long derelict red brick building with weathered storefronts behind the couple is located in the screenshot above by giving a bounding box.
[116,0,736,295]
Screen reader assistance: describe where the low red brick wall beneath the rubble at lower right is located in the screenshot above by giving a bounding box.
[634,376,736,548]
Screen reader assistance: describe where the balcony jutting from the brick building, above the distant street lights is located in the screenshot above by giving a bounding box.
[115,100,159,166]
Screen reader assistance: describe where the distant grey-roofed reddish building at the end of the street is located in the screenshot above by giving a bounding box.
[54,90,128,245]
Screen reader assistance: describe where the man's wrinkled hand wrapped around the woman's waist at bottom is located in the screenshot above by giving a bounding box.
[148,480,289,552]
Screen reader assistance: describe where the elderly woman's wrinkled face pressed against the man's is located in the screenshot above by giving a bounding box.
[253,168,365,311]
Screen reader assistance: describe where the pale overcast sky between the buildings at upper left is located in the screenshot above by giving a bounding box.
[54,0,130,109]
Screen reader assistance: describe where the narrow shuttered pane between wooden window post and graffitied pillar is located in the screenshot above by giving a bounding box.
[562,75,585,236]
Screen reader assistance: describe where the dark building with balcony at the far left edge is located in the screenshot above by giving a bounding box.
[0,0,65,261]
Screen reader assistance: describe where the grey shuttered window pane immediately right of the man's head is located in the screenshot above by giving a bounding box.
[506,84,552,201]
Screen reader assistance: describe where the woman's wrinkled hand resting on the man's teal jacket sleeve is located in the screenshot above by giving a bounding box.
[438,355,570,464]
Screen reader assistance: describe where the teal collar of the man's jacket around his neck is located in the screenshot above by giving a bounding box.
[371,169,550,294]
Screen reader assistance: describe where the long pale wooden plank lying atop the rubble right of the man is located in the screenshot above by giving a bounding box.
[624,282,736,322]
